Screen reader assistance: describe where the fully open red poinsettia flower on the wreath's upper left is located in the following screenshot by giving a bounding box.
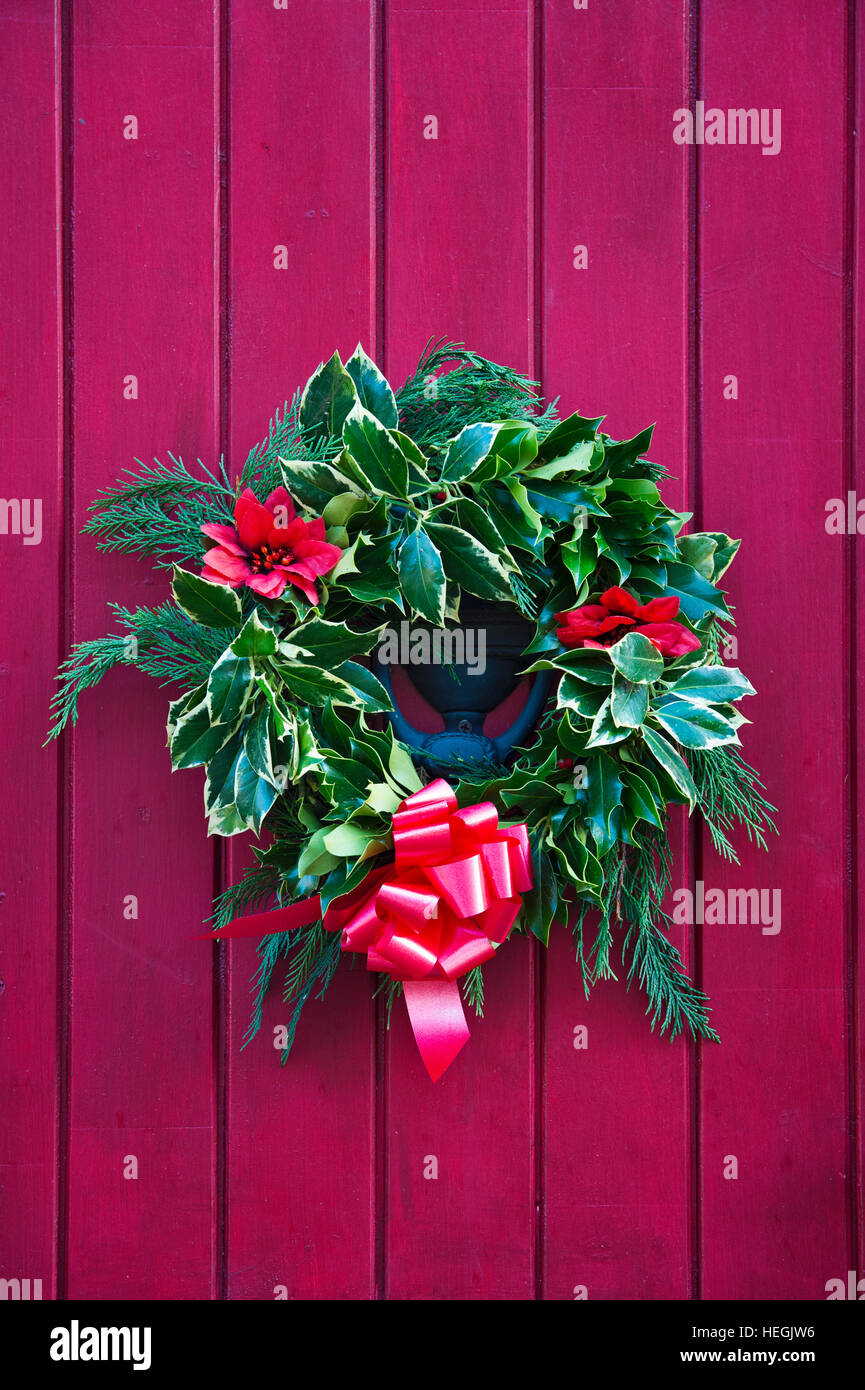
[202,488,342,603]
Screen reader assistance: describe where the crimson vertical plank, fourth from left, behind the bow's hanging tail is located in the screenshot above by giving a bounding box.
[385,0,534,1300]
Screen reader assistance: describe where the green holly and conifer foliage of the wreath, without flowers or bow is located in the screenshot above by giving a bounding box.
[49,341,773,1055]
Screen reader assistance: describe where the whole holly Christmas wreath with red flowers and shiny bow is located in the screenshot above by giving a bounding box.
[50,341,775,1080]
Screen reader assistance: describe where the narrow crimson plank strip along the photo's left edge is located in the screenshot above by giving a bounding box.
[0,0,63,1298]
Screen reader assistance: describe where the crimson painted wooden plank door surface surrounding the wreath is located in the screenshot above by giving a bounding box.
[0,0,865,1300]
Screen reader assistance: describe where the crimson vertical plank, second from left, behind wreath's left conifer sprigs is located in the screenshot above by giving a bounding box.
[68,0,216,1298]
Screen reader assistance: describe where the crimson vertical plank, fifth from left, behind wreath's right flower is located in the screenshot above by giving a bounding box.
[542,0,691,1300]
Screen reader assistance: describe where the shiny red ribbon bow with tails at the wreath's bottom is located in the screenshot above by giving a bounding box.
[213,777,533,1081]
